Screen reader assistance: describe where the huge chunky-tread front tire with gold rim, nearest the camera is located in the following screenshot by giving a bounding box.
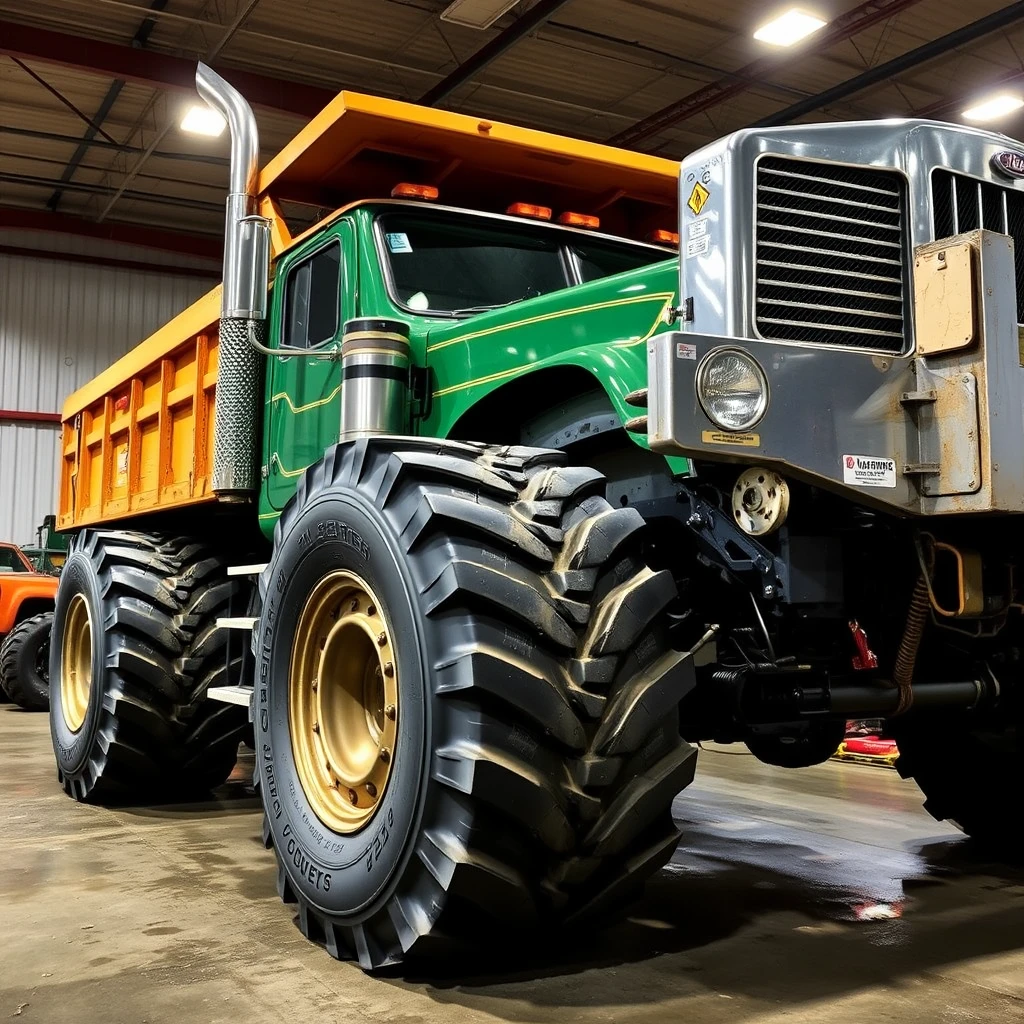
[255,437,696,970]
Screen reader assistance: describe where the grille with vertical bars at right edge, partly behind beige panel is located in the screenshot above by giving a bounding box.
[932,170,1024,324]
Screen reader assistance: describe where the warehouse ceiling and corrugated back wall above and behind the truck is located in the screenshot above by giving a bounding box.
[6,0,1022,543]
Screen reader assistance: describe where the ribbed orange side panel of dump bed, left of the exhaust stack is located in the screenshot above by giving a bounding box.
[57,299,218,529]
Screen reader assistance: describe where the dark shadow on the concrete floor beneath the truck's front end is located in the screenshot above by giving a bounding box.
[385,837,1024,1020]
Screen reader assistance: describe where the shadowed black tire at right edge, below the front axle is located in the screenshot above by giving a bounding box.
[891,717,1024,843]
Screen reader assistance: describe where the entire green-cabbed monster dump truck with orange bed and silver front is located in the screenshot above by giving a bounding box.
[50,66,1024,970]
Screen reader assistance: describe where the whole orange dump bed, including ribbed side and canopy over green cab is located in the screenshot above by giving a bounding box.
[57,92,679,529]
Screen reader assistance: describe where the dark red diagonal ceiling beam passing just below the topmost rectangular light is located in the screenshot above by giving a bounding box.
[608,0,921,146]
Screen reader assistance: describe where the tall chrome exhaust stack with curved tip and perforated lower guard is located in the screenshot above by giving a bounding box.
[196,63,270,501]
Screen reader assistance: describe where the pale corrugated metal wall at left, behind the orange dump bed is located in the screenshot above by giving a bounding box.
[0,231,214,544]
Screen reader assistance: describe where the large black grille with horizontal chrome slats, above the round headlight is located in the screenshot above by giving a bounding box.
[755,157,906,352]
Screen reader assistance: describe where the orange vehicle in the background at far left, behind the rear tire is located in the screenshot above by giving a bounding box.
[0,543,57,711]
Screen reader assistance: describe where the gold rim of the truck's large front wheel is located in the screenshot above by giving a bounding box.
[288,569,398,835]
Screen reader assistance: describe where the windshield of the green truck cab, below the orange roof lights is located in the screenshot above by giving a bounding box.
[378,208,671,315]
